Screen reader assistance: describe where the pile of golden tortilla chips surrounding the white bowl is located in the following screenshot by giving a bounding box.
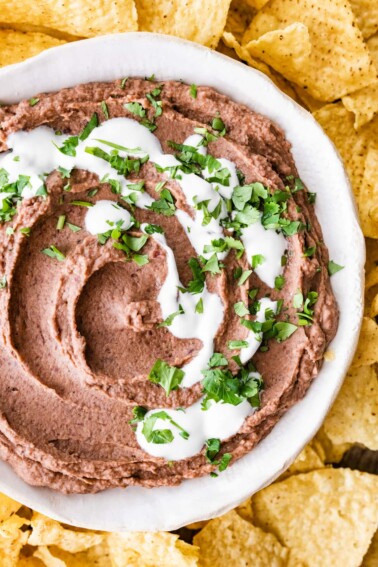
[0,0,378,567]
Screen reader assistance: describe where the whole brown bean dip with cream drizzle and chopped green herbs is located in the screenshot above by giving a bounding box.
[0,78,338,493]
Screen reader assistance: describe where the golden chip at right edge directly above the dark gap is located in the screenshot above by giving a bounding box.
[323,366,378,460]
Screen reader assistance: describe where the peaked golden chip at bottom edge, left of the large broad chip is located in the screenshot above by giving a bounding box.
[193,510,288,567]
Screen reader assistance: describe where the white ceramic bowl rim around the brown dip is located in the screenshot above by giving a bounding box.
[0,33,365,531]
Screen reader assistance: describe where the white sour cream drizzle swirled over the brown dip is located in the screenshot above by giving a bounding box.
[0,114,286,460]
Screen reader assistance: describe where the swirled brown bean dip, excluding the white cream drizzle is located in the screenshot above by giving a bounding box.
[0,79,338,493]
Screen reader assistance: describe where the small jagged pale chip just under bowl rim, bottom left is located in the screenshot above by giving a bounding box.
[28,512,103,553]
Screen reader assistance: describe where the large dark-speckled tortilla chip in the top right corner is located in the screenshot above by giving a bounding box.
[243,0,376,101]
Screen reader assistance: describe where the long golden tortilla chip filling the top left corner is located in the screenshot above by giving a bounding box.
[0,0,138,37]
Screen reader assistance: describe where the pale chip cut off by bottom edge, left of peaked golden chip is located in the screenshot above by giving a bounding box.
[108,532,198,567]
